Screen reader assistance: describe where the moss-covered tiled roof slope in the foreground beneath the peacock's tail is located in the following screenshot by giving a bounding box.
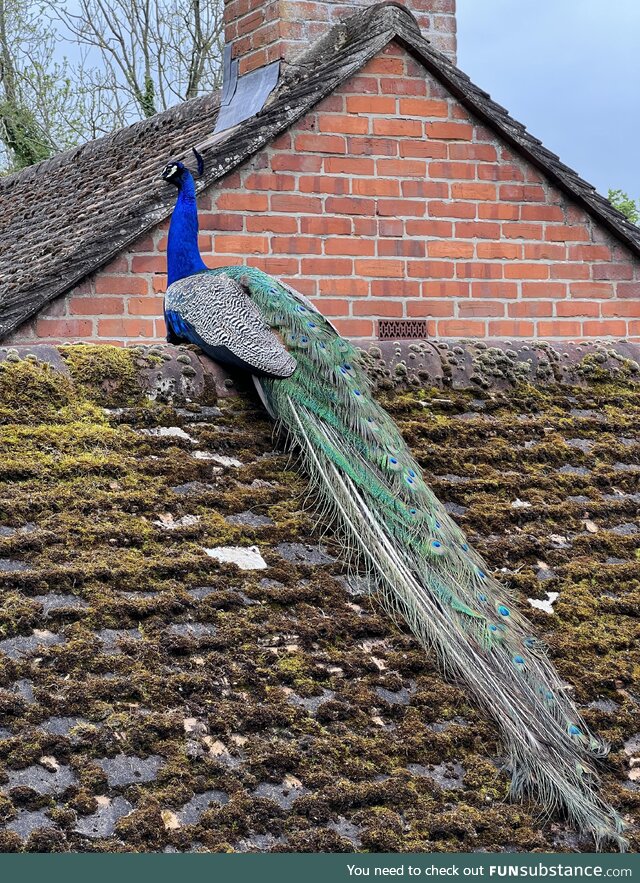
[0,347,640,852]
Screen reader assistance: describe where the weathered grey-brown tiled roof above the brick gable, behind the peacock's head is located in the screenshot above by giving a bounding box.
[0,3,640,338]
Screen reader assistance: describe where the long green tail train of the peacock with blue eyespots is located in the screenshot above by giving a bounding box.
[219,267,626,849]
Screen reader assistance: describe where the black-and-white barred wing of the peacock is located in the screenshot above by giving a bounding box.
[164,273,296,377]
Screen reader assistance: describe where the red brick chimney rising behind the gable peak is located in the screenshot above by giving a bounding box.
[224,0,456,75]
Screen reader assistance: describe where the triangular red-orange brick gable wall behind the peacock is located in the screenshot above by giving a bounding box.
[13,44,640,343]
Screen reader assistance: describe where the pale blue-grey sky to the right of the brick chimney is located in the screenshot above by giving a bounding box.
[457,0,640,198]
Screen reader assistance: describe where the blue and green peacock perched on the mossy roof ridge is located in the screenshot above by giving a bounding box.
[162,150,625,849]
